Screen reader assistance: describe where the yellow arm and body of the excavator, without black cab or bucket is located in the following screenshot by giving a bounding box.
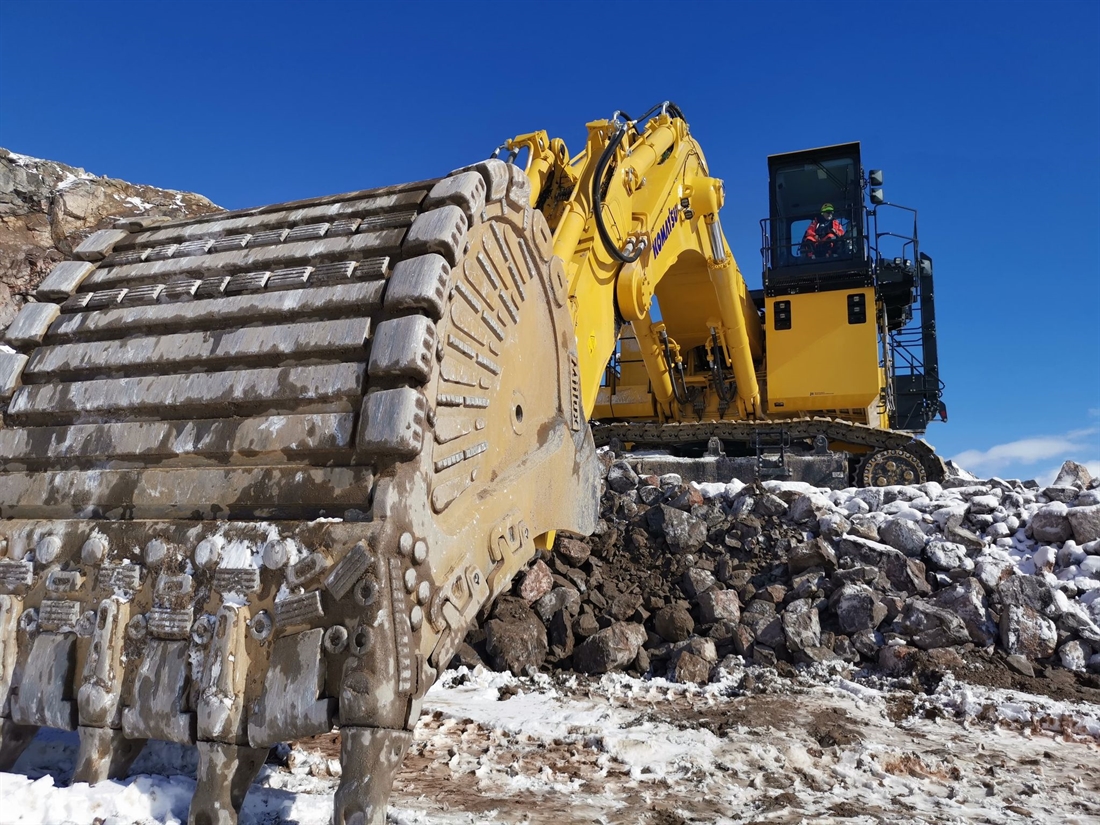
[532,113,902,440]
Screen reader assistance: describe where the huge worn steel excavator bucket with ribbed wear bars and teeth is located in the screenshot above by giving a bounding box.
[0,161,598,825]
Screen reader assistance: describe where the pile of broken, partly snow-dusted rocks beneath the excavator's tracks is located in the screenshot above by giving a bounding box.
[459,453,1100,682]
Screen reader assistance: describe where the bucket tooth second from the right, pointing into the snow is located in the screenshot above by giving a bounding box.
[187,741,271,825]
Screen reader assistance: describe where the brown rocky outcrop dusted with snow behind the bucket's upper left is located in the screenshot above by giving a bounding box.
[0,149,220,329]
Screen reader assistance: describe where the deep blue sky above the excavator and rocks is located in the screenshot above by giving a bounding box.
[0,0,1100,477]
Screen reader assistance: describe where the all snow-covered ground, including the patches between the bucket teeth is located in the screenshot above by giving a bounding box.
[0,659,1100,825]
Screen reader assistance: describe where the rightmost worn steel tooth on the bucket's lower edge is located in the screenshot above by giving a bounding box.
[332,727,413,825]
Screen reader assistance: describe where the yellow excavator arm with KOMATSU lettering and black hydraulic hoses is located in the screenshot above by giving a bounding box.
[505,103,763,420]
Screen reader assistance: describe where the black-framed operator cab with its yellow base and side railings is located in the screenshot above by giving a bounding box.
[761,143,942,440]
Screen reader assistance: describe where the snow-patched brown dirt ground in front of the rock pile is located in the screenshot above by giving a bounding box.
[290,659,1100,825]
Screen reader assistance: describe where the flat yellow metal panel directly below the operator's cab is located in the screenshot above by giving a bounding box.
[766,288,882,414]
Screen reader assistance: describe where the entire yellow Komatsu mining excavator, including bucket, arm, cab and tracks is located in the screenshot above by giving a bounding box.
[0,103,943,825]
